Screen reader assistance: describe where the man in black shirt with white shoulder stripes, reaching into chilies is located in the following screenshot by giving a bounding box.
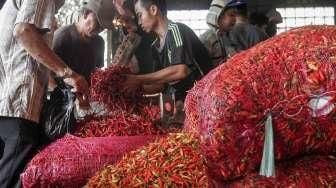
[125,0,212,123]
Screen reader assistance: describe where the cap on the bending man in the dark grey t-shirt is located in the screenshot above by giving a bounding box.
[84,0,115,29]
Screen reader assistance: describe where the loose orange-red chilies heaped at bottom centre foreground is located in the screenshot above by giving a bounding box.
[87,133,209,188]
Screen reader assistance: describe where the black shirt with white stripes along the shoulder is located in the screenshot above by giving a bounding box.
[153,21,212,100]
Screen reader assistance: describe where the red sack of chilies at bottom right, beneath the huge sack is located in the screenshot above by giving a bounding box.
[225,156,336,188]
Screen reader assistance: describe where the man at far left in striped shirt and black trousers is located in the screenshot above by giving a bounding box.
[0,0,88,188]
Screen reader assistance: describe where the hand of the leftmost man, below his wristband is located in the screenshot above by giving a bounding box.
[64,72,90,108]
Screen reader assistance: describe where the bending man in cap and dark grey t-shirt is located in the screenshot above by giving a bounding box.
[53,0,114,83]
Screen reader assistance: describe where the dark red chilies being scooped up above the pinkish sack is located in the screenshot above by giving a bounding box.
[74,65,179,137]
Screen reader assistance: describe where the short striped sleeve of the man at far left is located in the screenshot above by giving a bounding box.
[15,0,56,30]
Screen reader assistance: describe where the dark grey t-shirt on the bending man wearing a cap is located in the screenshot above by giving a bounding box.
[53,24,104,81]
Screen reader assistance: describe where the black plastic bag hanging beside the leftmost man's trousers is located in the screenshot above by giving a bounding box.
[40,80,76,142]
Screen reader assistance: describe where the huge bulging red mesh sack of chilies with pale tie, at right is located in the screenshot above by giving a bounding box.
[185,26,336,180]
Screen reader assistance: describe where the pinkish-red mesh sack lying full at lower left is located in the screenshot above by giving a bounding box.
[21,135,156,188]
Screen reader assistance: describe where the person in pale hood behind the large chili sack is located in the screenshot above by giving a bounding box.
[200,0,239,66]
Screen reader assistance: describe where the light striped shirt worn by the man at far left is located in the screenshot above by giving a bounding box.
[0,0,64,123]
